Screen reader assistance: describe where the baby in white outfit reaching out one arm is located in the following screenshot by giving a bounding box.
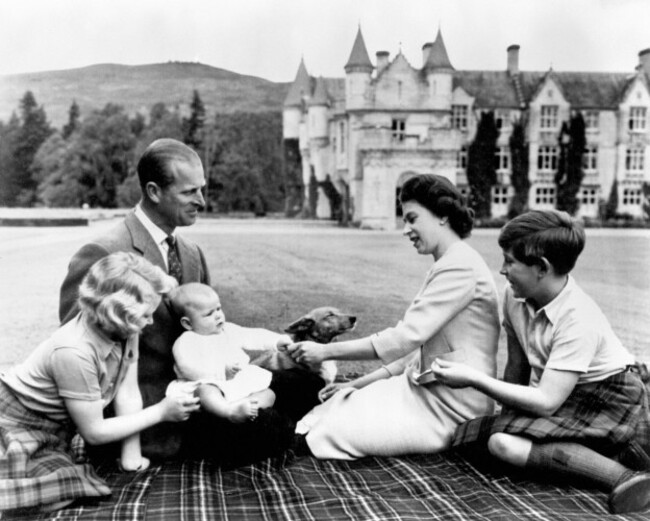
[168,282,291,423]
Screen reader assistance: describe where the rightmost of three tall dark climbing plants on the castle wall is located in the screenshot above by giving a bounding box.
[555,112,587,215]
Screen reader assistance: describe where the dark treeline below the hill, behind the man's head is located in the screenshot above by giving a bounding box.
[0,91,295,215]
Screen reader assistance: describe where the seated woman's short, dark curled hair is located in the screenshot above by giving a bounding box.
[399,174,474,239]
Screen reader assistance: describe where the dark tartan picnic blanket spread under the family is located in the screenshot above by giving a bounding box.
[3,452,648,521]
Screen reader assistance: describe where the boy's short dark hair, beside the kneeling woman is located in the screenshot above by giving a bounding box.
[499,210,585,275]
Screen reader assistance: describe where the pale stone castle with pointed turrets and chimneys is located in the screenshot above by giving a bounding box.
[283,27,650,229]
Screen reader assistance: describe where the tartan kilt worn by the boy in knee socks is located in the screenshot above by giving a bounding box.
[451,371,650,455]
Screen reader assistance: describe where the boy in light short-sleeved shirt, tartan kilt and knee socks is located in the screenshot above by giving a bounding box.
[432,210,650,513]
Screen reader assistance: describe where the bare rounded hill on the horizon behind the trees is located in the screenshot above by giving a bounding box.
[0,62,289,128]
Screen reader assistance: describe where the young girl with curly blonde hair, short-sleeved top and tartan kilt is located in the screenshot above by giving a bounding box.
[0,252,198,511]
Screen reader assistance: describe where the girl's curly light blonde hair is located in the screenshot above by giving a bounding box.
[79,252,177,338]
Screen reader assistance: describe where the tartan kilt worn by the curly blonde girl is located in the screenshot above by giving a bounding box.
[0,381,111,511]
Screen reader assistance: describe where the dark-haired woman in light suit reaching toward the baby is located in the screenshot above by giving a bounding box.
[288,175,499,460]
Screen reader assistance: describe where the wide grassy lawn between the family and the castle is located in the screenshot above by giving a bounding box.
[0,215,650,372]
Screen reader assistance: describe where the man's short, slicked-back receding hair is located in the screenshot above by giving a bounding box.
[138,138,201,193]
